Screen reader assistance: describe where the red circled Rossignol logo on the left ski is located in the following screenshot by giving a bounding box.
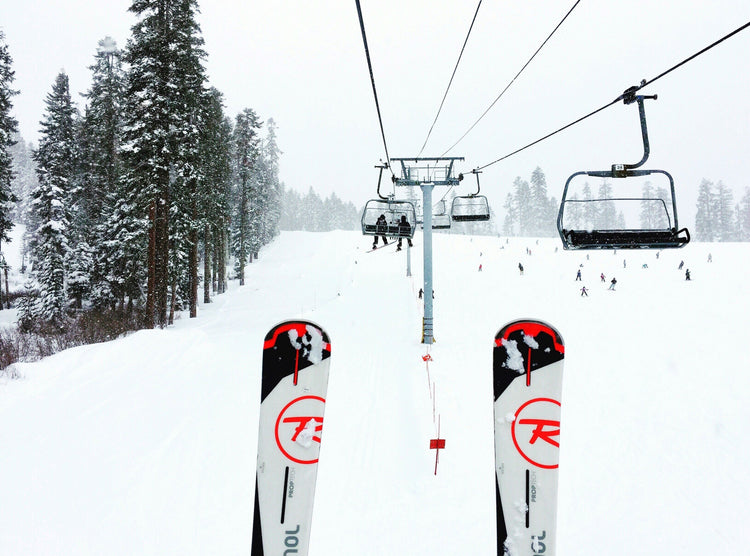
[275,396,326,464]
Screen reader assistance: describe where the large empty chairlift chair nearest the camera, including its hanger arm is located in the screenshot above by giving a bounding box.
[557,87,690,249]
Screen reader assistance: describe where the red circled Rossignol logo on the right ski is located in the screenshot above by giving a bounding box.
[511,398,560,469]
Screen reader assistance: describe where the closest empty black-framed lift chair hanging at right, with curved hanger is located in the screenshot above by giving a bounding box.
[557,87,690,249]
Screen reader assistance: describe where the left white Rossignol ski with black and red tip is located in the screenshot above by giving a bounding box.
[251,321,331,556]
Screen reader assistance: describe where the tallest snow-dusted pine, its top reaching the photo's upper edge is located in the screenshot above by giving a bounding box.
[123,0,205,327]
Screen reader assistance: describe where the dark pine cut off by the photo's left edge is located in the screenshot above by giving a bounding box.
[0,30,18,262]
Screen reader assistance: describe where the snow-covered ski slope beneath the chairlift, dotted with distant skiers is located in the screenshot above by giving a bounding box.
[0,232,750,556]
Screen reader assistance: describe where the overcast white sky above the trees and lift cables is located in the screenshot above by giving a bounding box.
[0,0,750,224]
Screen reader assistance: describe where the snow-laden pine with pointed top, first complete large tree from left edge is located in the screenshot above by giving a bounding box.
[31,72,76,331]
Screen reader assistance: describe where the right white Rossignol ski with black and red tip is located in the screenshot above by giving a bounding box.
[493,320,565,556]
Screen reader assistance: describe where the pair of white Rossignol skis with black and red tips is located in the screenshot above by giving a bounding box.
[251,320,565,556]
